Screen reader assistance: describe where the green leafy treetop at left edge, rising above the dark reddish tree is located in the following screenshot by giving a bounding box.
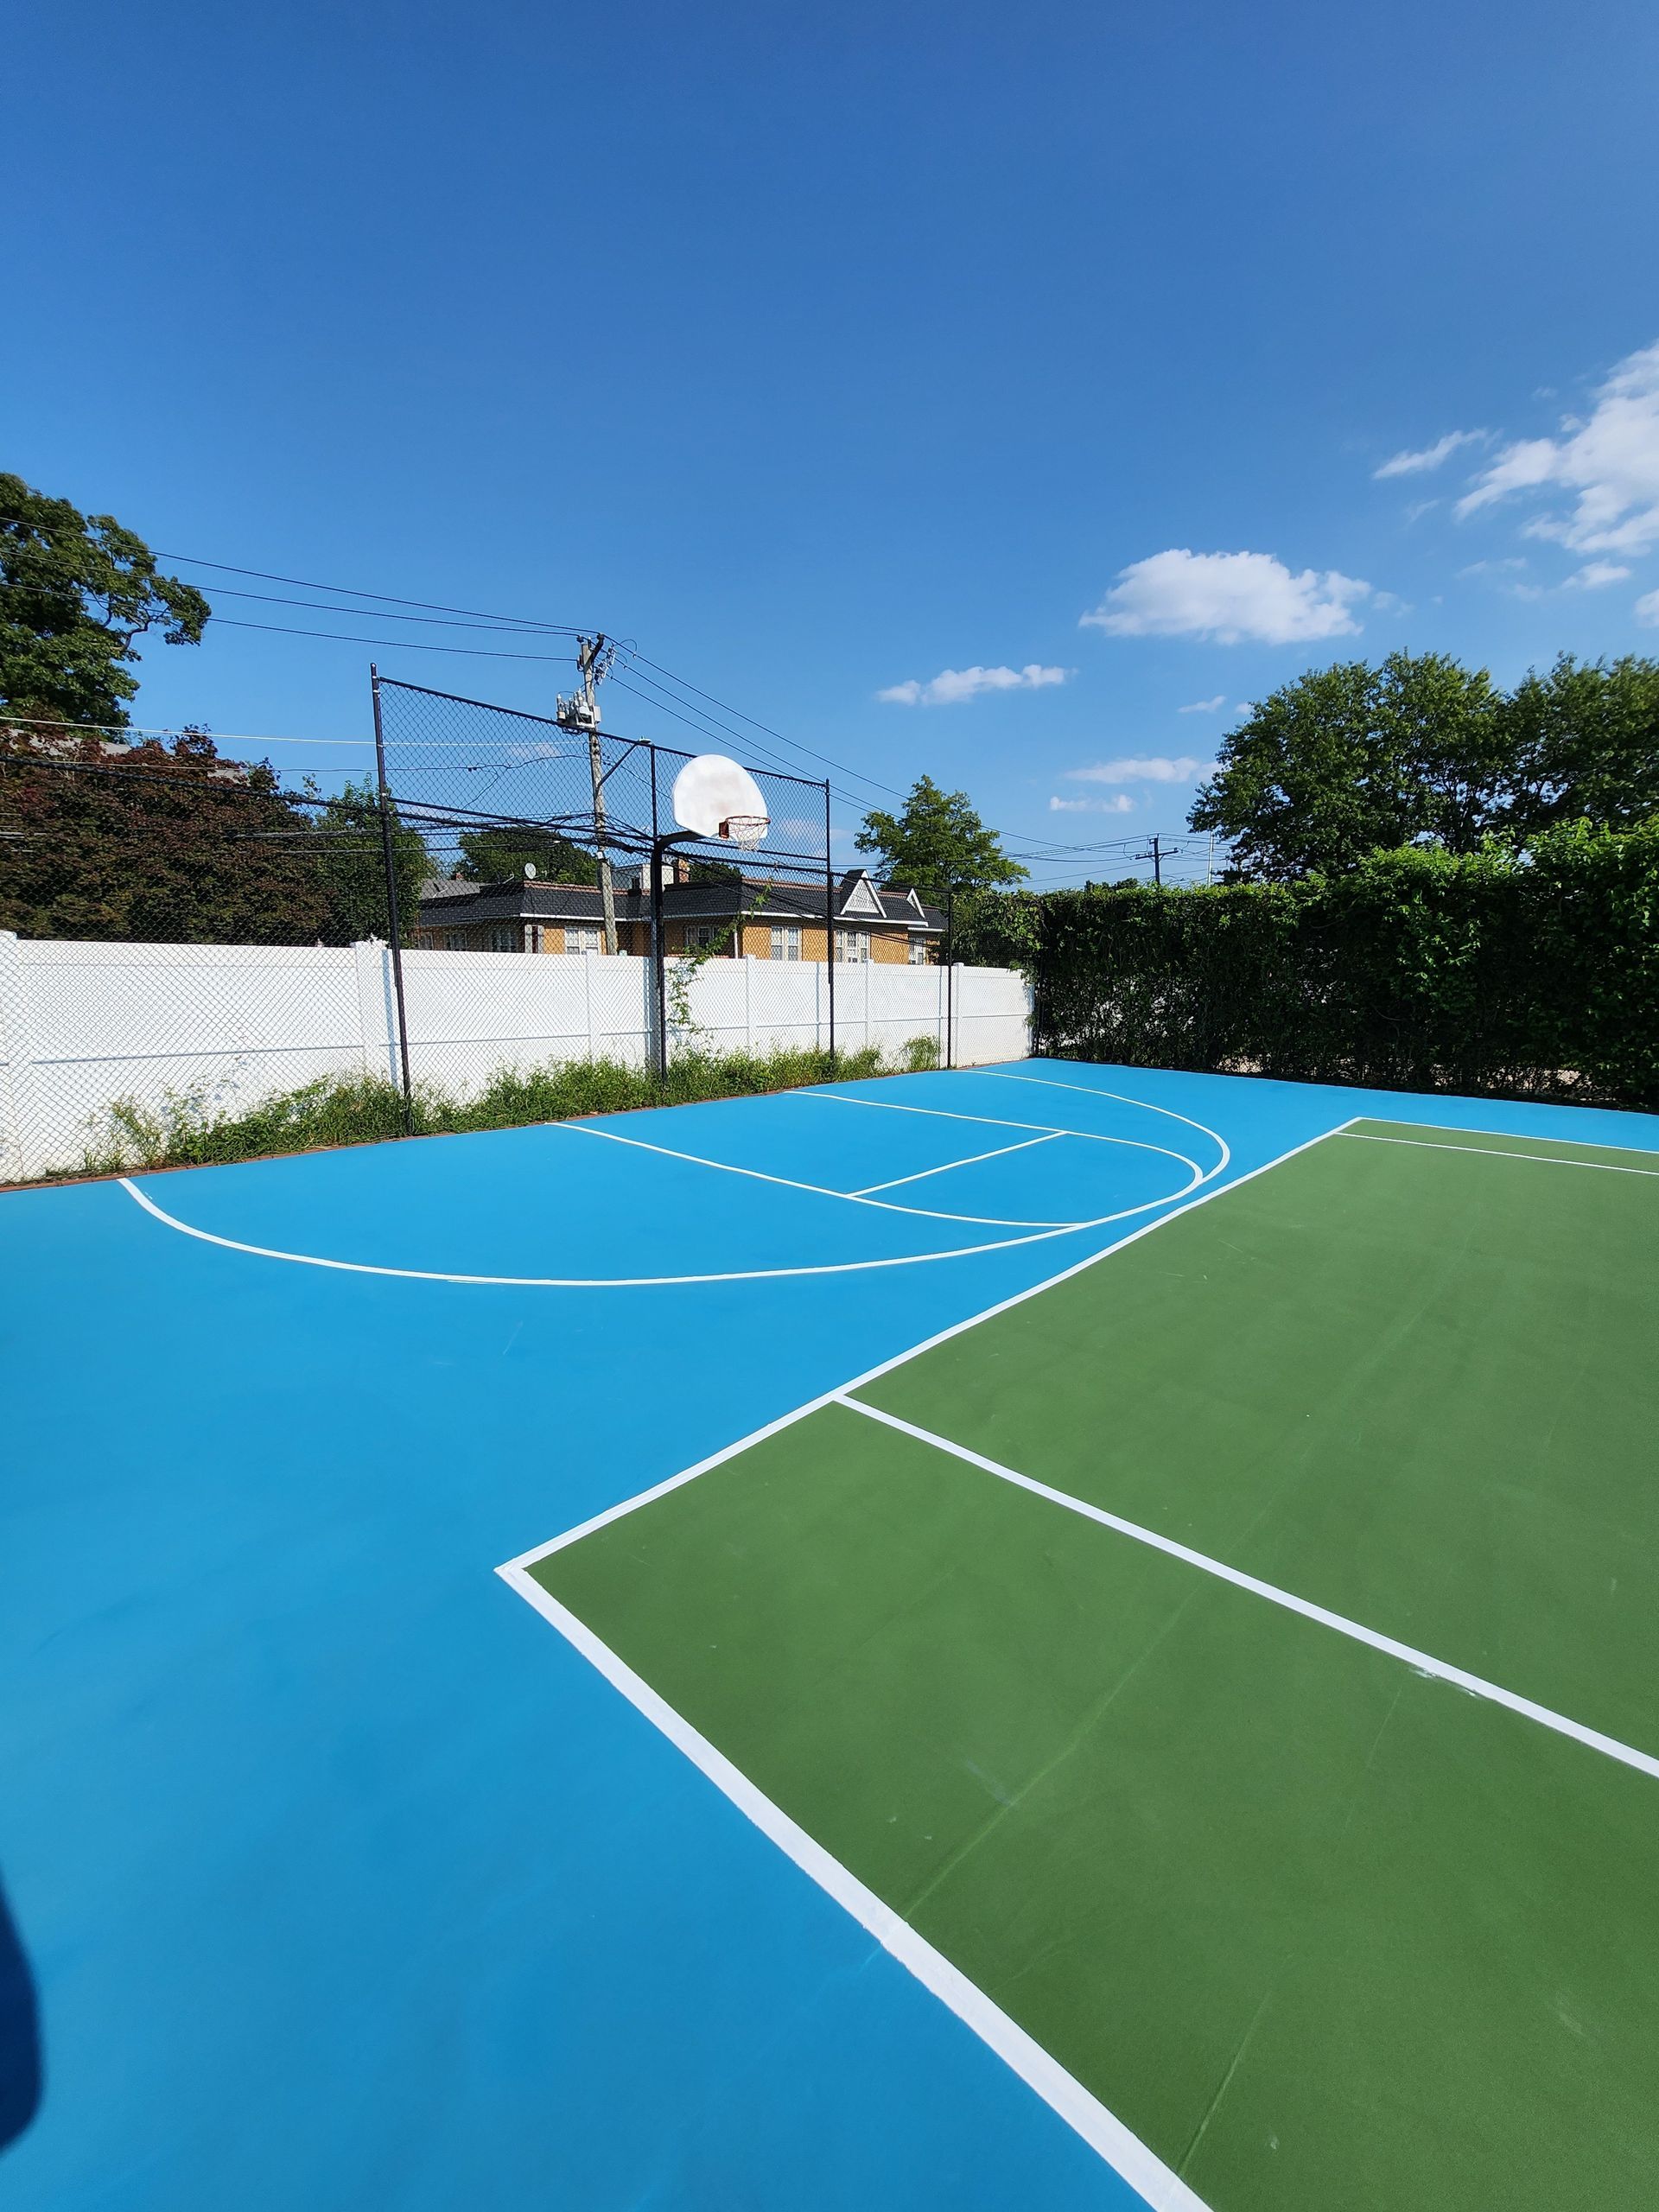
[0,474,213,728]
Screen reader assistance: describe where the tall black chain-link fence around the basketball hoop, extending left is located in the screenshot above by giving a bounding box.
[0,681,911,1181]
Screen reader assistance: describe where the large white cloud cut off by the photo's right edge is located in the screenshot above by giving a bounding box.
[1458,345,1659,553]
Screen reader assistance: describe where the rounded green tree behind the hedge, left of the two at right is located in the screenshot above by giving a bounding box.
[1188,652,1513,882]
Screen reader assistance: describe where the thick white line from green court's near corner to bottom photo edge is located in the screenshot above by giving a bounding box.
[495,1561,1205,2212]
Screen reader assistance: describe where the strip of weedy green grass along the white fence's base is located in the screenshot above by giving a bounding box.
[61,1038,938,1181]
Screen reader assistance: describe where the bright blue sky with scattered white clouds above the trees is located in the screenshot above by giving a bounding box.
[0,0,1659,876]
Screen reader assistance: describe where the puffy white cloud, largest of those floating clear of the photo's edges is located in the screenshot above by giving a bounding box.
[1082,546,1371,646]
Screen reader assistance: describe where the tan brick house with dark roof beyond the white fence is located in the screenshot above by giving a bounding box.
[411,856,944,967]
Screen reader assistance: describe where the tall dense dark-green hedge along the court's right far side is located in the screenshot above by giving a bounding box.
[957,818,1659,1109]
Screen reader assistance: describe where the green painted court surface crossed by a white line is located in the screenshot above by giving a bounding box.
[529,1122,1659,2212]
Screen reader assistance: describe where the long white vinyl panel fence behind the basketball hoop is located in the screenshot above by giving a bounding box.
[0,931,1031,1181]
